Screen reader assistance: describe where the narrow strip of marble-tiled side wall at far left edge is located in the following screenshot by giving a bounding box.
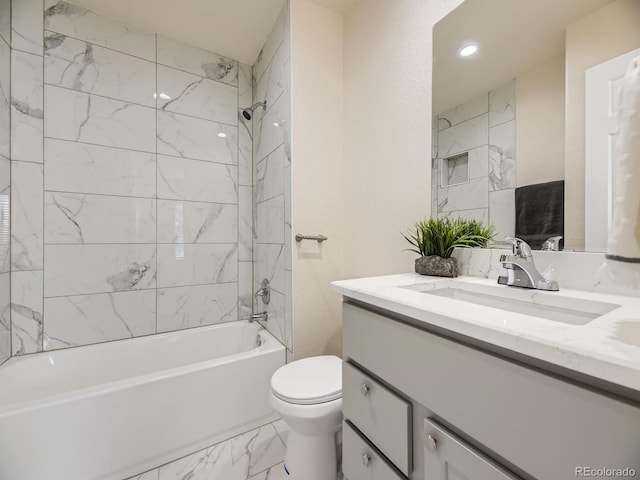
[0,0,11,364]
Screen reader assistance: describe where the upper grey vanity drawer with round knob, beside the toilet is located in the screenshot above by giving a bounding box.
[342,362,411,476]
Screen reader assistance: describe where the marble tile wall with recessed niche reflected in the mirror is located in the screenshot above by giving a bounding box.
[431,80,516,241]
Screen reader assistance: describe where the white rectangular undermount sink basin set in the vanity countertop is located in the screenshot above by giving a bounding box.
[402,280,620,325]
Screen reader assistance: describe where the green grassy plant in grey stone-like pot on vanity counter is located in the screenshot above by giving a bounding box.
[403,218,495,277]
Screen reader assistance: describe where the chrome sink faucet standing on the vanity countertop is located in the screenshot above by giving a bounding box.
[498,237,560,291]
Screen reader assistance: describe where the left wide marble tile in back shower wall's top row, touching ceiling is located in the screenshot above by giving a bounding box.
[44,1,156,62]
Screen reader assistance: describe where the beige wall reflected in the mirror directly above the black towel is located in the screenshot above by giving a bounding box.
[516,56,564,187]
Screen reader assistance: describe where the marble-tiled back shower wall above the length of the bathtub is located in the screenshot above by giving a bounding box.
[6,0,252,355]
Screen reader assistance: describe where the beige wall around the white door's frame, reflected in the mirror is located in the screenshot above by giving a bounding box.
[565,0,640,250]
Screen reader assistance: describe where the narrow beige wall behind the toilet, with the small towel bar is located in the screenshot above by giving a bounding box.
[291,0,344,358]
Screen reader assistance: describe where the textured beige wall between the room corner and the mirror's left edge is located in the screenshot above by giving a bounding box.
[344,0,462,277]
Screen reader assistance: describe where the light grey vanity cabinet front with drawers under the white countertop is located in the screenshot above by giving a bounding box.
[343,302,640,480]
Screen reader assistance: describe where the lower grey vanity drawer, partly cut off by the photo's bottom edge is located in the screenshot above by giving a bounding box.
[342,422,404,480]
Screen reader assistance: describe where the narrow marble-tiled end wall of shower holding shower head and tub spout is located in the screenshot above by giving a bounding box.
[253,2,293,352]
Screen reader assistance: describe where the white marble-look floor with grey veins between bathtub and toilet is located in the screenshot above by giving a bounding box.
[128,421,287,480]
